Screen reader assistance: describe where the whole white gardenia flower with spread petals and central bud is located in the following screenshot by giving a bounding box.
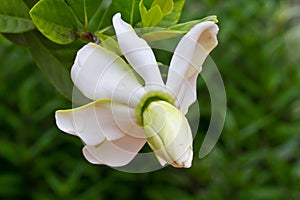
[55,13,218,168]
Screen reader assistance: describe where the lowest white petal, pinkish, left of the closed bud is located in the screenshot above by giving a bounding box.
[83,135,146,167]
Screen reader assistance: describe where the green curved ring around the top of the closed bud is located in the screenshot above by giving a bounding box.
[135,91,174,126]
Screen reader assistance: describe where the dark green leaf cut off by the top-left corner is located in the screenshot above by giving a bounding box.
[0,0,34,33]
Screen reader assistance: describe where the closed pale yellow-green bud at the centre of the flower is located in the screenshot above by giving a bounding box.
[143,101,193,168]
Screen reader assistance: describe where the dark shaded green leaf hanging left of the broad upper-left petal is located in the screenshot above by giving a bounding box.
[24,32,81,100]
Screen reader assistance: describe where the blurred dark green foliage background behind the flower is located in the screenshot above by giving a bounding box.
[0,0,300,200]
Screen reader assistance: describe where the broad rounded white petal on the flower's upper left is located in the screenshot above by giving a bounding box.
[71,43,141,103]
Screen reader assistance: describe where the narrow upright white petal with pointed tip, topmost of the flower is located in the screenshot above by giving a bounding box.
[113,13,163,85]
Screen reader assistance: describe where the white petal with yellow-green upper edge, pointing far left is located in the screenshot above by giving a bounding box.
[55,100,144,145]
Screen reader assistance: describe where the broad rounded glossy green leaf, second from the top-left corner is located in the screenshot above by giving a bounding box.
[30,0,77,44]
